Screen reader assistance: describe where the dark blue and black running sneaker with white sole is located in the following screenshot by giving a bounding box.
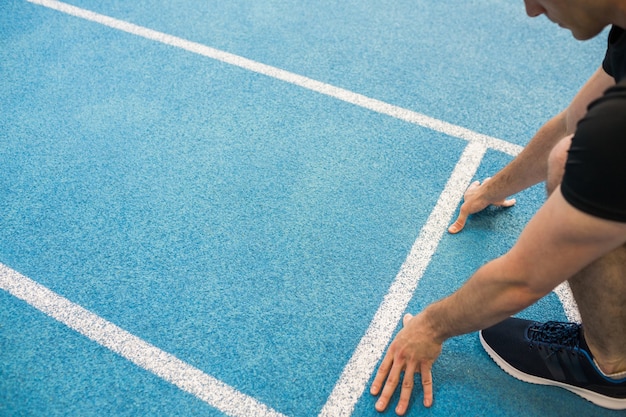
[480,318,626,410]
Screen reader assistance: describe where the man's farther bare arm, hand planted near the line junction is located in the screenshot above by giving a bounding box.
[448,67,615,233]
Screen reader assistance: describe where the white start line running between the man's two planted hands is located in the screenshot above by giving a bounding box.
[319,143,487,417]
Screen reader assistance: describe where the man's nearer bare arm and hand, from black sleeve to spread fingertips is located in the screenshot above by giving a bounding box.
[371,188,626,414]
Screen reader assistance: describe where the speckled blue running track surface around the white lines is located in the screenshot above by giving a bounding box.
[0,0,610,416]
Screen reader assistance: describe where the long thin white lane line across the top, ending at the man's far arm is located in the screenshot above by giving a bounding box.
[28,0,522,156]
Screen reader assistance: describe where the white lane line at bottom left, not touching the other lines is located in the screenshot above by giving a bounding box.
[0,264,284,417]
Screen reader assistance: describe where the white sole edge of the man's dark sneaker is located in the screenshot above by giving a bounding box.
[479,332,626,410]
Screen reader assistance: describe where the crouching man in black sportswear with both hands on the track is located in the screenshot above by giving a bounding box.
[371,0,626,415]
